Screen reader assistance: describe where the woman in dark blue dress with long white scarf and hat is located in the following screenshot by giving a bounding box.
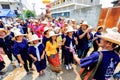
[28,34,46,75]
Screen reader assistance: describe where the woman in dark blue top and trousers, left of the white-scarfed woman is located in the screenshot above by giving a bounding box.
[13,32,32,74]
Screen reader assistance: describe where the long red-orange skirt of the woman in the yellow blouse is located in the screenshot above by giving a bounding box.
[48,53,61,73]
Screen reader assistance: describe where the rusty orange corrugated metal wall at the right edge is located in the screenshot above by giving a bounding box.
[98,7,120,31]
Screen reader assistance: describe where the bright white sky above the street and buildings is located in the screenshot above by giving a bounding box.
[27,0,113,15]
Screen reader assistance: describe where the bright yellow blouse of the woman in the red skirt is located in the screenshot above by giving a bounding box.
[45,41,58,56]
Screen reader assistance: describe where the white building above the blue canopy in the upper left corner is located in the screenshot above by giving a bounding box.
[0,0,29,15]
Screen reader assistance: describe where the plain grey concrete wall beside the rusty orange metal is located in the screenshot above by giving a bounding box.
[70,5,101,27]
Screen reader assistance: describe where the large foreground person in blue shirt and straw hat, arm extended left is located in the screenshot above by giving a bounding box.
[74,29,120,80]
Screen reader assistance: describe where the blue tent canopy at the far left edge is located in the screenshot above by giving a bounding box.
[0,9,16,18]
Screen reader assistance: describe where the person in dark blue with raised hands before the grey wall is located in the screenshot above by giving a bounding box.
[77,21,92,58]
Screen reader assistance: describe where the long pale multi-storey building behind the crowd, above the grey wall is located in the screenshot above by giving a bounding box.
[50,0,100,18]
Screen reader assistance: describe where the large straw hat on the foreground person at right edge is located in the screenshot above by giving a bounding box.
[98,28,120,44]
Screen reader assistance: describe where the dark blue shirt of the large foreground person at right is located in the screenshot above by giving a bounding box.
[80,51,120,80]
